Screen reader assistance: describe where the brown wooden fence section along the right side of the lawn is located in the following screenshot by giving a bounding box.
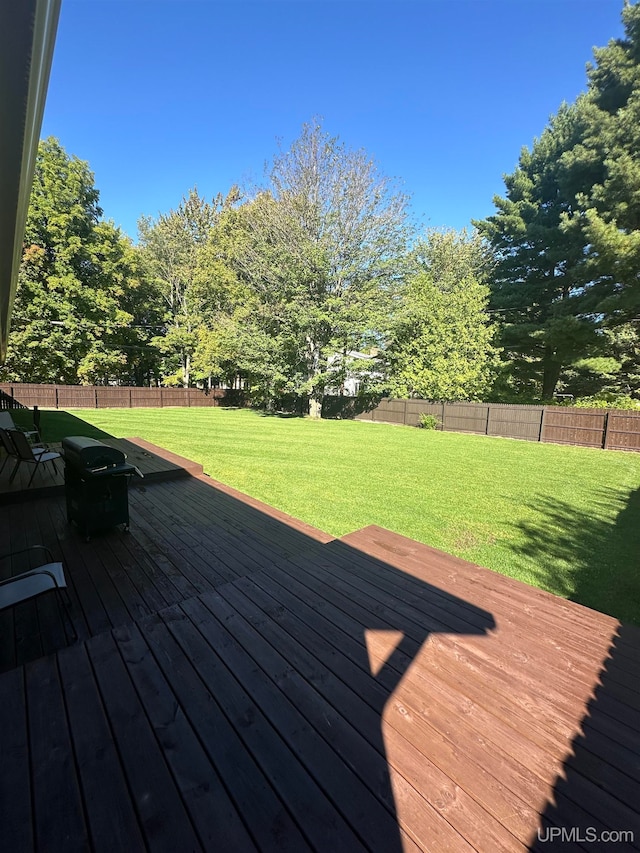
[356,398,640,451]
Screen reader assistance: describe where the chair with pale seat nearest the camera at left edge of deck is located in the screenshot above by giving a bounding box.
[0,545,78,640]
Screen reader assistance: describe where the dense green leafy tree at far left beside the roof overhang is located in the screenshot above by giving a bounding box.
[2,138,160,383]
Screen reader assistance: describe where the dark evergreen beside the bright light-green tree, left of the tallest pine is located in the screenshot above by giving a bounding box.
[475,101,600,399]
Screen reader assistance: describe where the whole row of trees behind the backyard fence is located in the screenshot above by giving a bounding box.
[5,0,640,415]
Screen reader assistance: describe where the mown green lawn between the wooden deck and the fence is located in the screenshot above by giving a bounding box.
[20,408,640,623]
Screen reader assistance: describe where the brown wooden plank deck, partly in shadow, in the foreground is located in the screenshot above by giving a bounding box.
[0,463,640,853]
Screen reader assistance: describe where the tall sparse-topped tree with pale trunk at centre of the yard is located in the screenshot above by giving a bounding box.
[234,121,408,417]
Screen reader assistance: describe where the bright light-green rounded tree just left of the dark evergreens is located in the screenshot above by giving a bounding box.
[387,230,497,401]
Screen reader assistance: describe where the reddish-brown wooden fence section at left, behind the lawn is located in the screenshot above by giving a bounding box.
[0,383,228,409]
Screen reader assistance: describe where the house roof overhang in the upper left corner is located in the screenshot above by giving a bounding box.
[0,0,61,363]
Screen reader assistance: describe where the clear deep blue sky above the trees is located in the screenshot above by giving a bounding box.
[42,0,623,238]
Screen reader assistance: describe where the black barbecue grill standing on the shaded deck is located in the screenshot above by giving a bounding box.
[62,436,142,539]
